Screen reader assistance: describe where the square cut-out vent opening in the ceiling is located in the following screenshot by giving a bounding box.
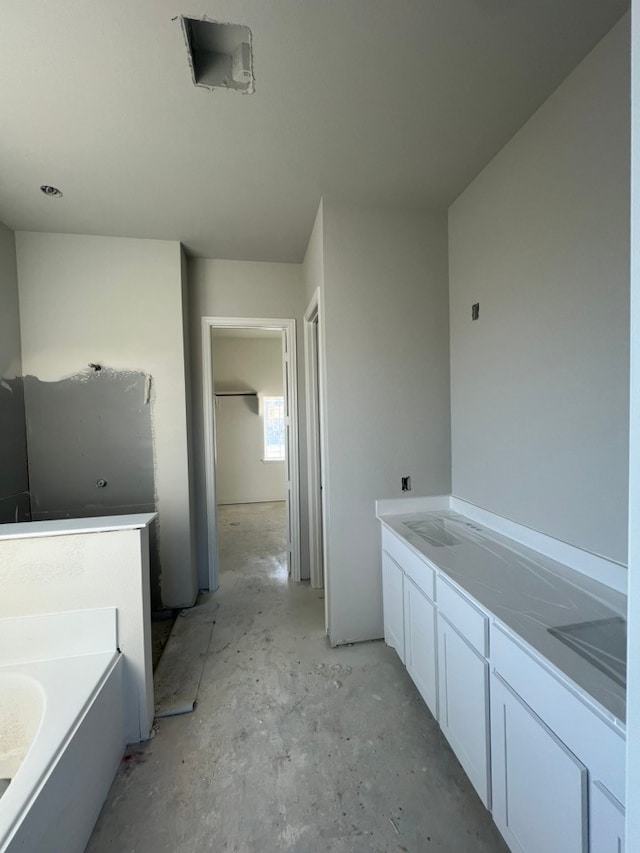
[180,16,254,94]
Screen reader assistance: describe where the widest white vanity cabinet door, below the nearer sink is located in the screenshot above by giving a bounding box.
[491,674,592,853]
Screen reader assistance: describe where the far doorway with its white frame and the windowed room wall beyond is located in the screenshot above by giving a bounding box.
[202,317,300,590]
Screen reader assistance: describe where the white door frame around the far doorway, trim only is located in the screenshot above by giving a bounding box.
[201,317,300,591]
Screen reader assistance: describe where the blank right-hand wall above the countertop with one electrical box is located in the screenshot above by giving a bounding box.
[449,17,629,563]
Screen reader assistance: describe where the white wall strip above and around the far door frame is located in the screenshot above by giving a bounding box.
[189,259,309,588]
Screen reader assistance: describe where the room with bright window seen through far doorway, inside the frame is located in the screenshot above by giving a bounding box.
[211,328,289,579]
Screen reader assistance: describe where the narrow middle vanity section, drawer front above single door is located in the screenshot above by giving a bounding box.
[436,576,491,808]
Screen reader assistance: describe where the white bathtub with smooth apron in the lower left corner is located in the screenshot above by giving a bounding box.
[0,620,125,853]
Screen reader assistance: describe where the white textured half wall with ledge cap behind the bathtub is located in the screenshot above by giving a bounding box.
[0,513,155,743]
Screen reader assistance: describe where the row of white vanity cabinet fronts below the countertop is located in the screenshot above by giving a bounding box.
[382,525,625,853]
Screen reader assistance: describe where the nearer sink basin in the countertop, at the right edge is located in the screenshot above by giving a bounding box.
[547,616,627,687]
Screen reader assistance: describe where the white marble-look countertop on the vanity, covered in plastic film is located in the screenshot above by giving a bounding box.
[380,510,626,730]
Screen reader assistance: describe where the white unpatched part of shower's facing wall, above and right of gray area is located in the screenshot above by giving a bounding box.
[16,232,197,607]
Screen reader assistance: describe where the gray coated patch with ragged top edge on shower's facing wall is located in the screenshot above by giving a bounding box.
[24,369,162,609]
